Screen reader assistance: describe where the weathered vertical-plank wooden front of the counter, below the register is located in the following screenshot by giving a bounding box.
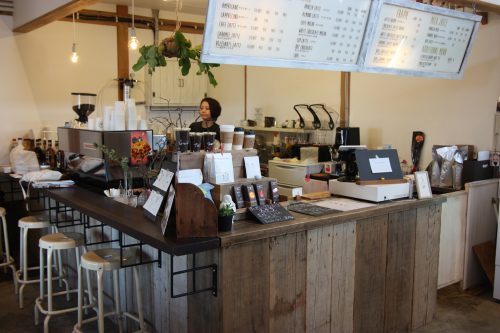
[188,197,446,333]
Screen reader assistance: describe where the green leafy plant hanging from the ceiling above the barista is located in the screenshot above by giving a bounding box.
[132,30,220,87]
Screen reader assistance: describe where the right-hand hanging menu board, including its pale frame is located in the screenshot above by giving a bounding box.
[363,0,480,78]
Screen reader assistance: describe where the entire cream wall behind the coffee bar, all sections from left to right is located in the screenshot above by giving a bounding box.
[0,5,500,166]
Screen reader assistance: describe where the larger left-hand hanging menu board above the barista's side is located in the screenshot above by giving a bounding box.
[202,0,372,71]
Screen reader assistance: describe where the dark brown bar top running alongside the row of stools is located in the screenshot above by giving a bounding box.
[46,186,220,256]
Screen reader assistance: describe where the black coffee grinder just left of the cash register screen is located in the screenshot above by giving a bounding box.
[332,127,360,181]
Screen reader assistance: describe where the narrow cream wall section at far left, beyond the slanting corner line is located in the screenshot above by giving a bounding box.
[0,16,40,164]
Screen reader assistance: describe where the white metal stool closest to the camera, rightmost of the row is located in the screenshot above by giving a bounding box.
[73,249,145,333]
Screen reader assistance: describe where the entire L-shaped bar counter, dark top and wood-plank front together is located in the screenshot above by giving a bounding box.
[48,188,446,333]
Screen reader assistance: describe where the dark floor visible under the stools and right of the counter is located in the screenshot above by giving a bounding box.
[0,270,500,333]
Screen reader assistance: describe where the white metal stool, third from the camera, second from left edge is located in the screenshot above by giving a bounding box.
[16,215,68,309]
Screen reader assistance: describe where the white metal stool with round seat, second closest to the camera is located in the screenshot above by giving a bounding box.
[35,232,92,333]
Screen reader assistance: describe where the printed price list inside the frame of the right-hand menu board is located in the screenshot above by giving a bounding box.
[365,4,475,73]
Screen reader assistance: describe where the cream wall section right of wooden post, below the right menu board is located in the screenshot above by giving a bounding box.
[350,14,500,168]
